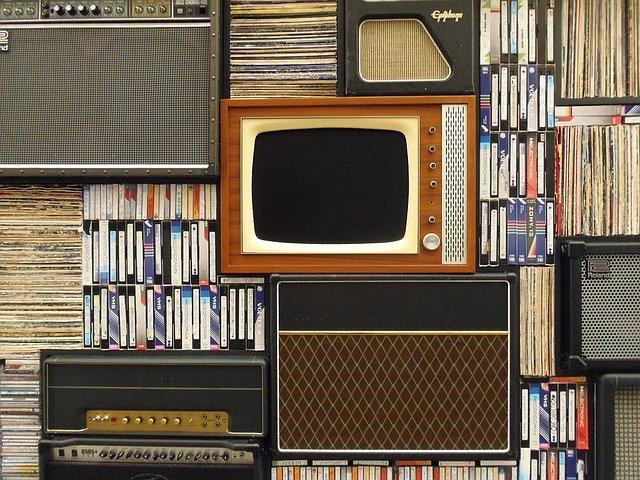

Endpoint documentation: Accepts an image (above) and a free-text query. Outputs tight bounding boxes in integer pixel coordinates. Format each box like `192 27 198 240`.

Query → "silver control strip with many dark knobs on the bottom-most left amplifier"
51 445 253 465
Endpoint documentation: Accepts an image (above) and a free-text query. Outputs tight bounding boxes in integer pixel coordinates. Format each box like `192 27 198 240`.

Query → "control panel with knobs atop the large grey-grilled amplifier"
0 0 210 19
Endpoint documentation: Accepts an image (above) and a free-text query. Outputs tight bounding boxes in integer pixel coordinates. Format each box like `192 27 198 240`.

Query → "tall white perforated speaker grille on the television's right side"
442 105 467 265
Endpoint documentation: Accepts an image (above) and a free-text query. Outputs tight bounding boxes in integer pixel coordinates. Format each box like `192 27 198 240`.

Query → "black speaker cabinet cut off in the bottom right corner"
595 373 640 480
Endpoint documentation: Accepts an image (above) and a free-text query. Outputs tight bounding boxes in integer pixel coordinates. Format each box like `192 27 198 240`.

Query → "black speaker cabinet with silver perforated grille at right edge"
560 237 640 372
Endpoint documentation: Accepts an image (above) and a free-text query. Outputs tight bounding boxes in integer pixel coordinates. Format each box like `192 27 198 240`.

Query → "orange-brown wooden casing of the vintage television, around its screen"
220 95 477 273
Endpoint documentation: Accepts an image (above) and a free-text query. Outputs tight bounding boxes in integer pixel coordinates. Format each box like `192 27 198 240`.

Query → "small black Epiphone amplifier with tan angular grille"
344 0 478 95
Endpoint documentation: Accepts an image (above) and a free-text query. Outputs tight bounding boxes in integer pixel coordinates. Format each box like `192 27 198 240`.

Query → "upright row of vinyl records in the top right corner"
560 0 640 98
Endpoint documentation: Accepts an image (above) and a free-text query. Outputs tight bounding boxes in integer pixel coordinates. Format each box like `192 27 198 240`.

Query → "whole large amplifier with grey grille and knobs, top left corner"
0 0 220 177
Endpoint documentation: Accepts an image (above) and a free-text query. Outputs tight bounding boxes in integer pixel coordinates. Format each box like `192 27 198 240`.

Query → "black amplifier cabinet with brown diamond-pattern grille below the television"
271 275 518 458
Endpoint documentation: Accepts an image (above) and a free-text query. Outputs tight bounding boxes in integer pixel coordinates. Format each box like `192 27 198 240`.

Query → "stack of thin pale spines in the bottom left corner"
0 353 40 480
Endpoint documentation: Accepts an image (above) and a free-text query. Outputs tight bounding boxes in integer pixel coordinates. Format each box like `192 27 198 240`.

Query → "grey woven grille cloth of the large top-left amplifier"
0 25 211 166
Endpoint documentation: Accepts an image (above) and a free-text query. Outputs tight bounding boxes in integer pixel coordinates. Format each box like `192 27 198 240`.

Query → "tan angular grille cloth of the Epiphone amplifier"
360 19 451 82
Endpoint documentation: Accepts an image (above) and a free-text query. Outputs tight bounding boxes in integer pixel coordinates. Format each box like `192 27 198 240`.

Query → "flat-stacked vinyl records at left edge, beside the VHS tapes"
0 186 82 351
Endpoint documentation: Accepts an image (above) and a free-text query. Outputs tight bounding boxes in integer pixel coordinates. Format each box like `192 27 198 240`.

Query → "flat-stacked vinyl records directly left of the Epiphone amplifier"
230 0 337 97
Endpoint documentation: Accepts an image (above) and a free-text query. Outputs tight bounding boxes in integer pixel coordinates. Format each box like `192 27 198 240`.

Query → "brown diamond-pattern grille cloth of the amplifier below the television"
279 333 509 450
